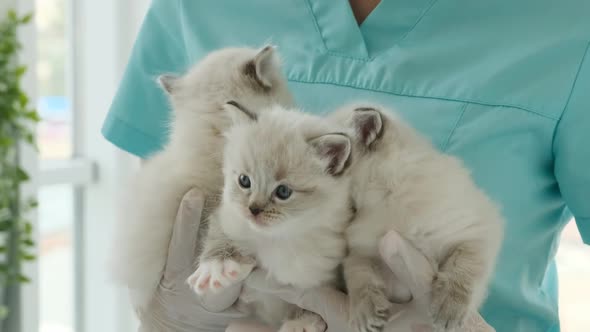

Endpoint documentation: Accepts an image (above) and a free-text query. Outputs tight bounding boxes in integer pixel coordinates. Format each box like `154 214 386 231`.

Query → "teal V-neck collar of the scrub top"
304 0 435 60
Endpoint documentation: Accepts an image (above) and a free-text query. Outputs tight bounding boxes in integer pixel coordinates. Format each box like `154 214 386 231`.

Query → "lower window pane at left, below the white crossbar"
39 185 75 332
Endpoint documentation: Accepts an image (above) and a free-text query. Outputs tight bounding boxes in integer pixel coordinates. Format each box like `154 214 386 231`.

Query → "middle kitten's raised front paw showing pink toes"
187 259 254 295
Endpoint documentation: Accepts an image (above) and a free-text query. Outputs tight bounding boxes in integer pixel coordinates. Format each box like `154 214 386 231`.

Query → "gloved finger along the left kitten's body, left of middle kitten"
164 188 205 282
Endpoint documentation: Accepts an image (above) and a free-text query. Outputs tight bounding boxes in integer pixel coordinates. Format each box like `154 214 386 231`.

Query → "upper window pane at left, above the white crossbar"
35 0 72 159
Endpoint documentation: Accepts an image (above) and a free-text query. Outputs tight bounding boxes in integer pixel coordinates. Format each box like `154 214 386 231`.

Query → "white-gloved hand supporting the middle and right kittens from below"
243 231 495 332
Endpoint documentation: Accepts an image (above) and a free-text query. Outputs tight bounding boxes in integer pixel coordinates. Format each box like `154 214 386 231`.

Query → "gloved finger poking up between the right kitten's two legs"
379 231 435 297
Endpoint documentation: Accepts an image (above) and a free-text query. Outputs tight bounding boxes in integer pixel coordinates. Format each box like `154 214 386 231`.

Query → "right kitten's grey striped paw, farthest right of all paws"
431 273 470 331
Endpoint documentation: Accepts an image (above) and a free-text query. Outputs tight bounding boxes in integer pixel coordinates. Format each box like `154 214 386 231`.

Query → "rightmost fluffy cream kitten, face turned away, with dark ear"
331 106 503 332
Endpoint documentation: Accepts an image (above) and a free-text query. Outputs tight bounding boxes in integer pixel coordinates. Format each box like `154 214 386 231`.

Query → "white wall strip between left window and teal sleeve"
72 0 148 332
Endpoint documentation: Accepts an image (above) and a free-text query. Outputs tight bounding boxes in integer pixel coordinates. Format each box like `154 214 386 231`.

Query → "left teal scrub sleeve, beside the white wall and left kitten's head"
102 0 188 158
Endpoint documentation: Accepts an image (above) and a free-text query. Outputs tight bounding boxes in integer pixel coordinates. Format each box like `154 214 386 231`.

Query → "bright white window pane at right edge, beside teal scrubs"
556 221 590 332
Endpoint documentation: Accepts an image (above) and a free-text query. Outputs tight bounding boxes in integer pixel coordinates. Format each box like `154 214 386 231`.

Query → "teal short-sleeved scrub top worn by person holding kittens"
103 0 590 332
